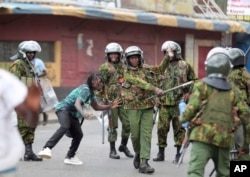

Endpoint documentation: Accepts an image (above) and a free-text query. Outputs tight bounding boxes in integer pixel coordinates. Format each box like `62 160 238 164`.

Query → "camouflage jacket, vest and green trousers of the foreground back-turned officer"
180 81 250 177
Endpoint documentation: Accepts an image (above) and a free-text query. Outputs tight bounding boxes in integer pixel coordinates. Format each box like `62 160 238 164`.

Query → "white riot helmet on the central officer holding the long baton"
125 46 144 67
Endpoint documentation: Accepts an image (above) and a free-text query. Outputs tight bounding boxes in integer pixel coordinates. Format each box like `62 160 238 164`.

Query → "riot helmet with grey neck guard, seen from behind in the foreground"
203 47 232 90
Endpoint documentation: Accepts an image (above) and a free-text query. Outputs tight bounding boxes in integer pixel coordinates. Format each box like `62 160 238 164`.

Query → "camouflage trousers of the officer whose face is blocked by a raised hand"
157 105 185 147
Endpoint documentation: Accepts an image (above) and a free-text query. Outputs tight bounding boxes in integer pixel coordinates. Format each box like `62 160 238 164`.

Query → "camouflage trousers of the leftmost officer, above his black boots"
17 118 35 144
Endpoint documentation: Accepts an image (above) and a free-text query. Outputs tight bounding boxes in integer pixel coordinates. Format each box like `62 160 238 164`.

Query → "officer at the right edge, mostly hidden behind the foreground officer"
228 48 250 160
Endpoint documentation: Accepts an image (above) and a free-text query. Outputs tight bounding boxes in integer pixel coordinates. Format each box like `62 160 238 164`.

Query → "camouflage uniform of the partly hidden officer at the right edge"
228 67 250 160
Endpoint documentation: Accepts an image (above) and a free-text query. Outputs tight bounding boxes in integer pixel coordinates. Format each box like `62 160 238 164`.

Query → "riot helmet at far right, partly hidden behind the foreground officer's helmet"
227 48 246 68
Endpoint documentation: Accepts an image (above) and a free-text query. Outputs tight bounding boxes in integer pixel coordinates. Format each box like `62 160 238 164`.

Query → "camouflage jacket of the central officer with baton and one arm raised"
121 57 168 109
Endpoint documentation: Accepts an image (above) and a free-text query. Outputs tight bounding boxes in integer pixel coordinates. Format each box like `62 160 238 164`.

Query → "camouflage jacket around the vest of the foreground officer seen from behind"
180 81 250 148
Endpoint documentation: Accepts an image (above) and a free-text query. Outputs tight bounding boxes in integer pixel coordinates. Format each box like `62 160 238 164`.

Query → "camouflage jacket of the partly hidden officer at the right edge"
228 68 250 106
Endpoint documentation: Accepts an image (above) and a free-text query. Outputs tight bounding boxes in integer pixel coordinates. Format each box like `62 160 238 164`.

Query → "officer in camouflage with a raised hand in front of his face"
153 41 195 163
